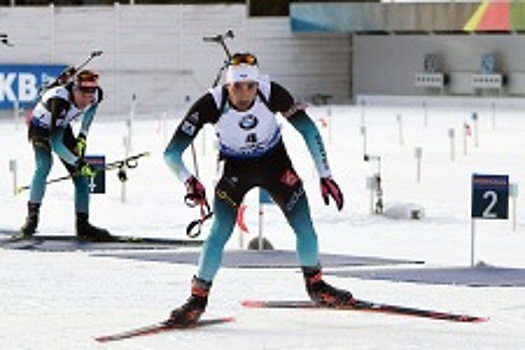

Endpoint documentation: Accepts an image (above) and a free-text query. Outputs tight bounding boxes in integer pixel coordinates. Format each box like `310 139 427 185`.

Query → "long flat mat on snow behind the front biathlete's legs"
97 250 423 268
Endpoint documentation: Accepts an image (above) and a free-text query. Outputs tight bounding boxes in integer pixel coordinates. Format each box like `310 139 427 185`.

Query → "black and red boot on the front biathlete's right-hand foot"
302 266 354 307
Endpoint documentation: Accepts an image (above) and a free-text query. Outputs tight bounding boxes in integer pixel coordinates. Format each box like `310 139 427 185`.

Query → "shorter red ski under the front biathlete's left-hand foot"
95 317 235 343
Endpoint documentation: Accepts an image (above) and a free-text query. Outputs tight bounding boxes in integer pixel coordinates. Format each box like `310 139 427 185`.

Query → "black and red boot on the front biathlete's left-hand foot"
166 277 211 327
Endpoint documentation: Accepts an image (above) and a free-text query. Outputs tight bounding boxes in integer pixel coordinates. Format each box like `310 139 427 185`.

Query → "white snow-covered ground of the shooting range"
0 100 525 349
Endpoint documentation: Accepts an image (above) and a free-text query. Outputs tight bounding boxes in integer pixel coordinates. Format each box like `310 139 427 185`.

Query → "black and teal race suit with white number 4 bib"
164 80 330 281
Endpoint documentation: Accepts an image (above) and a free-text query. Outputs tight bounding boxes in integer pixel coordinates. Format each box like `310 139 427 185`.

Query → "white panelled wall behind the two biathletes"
0 4 352 115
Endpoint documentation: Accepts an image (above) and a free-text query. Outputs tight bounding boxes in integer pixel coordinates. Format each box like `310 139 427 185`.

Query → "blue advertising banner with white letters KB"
0 64 68 109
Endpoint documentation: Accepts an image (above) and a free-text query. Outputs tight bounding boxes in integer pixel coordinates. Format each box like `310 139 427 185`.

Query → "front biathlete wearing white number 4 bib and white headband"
164 53 353 325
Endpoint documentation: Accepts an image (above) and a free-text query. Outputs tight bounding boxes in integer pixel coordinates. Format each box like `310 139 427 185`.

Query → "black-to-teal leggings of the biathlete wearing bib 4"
197 144 319 281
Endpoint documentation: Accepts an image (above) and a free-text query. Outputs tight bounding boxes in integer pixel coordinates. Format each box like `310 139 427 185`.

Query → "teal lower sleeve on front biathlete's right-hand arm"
287 111 331 177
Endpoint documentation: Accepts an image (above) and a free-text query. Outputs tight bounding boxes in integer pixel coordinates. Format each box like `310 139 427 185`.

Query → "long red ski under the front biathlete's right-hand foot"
242 299 488 322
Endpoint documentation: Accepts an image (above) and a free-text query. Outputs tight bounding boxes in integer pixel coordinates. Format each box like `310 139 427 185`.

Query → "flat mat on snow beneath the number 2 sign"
325 266 525 287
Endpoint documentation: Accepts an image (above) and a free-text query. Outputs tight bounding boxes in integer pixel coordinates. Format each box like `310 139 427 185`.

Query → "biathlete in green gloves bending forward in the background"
18 70 113 242
